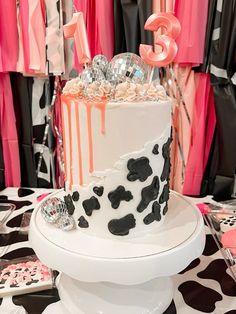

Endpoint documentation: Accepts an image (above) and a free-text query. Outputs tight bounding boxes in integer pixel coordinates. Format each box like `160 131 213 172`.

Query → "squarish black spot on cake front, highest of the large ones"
127 157 152 182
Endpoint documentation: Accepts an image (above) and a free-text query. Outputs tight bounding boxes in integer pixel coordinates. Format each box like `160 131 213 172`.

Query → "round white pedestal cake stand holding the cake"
29 191 205 314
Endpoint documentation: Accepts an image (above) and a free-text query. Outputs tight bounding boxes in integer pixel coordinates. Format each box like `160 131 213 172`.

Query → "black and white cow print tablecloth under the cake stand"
0 188 236 314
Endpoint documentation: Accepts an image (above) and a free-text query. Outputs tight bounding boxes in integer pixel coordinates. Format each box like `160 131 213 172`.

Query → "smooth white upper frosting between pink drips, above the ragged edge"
62 100 171 186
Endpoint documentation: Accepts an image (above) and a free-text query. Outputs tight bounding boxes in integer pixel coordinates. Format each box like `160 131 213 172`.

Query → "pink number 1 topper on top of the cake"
63 12 91 64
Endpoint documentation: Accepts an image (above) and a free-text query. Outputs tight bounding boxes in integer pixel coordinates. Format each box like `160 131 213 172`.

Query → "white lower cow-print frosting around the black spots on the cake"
73 125 170 238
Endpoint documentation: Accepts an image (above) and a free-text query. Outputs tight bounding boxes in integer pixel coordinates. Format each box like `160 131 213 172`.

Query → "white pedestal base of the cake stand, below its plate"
43 274 173 314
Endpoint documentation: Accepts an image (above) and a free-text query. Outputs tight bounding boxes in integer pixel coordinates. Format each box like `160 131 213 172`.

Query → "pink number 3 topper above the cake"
139 13 181 67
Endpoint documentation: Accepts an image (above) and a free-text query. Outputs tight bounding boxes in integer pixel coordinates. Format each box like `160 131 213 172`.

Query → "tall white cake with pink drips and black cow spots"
61 79 171 238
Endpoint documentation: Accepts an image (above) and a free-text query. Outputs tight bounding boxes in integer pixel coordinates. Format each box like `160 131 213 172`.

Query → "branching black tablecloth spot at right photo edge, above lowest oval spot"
197 259 236 297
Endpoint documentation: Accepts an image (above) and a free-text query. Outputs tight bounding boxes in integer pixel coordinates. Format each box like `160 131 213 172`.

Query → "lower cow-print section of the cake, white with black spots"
60 126 171 237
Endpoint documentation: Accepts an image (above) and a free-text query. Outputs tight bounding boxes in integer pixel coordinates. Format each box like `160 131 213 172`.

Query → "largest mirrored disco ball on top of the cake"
106 52 149 85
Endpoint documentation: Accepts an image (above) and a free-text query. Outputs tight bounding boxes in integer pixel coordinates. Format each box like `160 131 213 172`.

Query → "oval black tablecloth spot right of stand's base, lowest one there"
178 281 223 313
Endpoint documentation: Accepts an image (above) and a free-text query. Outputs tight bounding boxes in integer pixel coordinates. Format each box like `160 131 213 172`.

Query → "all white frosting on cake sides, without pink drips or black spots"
62 96 171 238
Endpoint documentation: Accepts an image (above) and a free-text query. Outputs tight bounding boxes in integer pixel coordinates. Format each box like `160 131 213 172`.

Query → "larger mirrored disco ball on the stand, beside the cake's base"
41 197 68 224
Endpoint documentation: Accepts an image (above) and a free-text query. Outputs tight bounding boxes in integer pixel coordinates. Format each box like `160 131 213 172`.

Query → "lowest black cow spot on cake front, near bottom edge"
108 214 136 236
